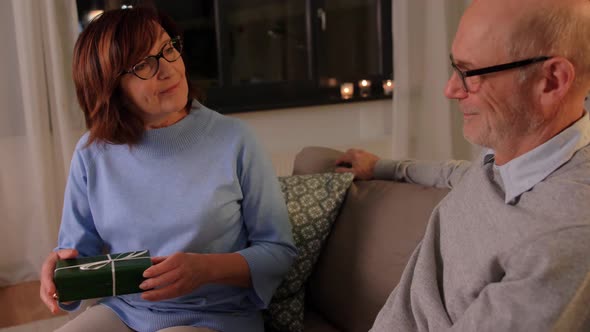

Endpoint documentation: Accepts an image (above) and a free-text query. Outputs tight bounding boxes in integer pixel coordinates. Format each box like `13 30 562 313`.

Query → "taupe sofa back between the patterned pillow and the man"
293 147 448 332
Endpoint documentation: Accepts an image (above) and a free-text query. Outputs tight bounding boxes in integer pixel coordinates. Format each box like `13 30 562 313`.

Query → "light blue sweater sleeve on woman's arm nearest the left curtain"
55 140 103 256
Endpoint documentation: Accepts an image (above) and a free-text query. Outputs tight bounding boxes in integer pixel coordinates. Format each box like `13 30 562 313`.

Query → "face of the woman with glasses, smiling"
121 28 188 129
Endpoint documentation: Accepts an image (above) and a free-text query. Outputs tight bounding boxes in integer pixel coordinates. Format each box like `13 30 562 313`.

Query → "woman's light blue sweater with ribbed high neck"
57 101 296 332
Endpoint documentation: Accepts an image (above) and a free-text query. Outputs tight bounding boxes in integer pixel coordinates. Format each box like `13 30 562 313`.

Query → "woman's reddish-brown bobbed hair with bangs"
72 7 198 145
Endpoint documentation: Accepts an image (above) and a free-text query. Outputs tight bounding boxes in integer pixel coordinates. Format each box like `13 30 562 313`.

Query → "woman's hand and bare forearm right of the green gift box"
139 253 252 301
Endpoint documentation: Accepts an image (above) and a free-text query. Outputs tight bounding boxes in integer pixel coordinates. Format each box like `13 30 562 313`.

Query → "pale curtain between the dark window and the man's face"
392 0 477 160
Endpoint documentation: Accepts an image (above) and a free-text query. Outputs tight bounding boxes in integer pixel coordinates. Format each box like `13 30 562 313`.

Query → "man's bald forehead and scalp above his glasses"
452 0 590 90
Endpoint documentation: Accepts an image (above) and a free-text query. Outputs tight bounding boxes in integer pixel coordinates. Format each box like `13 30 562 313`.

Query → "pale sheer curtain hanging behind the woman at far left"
0 0 84 286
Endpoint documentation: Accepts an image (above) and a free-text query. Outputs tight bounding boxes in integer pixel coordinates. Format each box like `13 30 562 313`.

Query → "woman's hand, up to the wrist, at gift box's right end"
139 253 209 301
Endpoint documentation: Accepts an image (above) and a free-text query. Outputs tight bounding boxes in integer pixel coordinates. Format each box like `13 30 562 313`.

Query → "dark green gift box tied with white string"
53 250 152 302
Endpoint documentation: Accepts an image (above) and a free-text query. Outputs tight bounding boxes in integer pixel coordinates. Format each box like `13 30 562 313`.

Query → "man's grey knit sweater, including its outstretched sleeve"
371 114 590 332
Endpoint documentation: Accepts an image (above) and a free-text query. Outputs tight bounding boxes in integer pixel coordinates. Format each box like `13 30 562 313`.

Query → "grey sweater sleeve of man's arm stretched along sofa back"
374 159 471 189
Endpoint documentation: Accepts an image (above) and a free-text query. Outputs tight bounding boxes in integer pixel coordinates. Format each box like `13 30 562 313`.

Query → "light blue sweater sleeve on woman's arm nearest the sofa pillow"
238 124 297 308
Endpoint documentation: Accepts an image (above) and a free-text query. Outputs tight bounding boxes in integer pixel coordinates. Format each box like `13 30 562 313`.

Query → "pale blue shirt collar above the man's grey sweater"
483 112 590 204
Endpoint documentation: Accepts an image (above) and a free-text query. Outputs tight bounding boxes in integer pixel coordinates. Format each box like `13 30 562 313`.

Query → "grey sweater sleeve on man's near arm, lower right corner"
449 225 590 331
